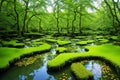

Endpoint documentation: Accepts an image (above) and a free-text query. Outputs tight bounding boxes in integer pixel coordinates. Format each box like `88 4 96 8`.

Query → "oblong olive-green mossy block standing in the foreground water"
71 63 93 80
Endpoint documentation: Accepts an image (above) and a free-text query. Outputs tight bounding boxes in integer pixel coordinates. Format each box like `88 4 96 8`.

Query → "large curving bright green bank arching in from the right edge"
47 44 120 68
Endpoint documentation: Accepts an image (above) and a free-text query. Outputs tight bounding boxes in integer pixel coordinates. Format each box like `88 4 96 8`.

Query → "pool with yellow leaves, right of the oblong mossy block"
83 60 119 80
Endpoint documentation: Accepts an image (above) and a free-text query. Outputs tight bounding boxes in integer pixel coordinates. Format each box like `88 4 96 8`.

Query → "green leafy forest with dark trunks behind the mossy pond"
0 0 120 35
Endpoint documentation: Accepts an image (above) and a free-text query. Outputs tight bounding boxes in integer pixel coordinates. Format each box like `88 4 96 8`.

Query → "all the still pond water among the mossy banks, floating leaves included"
0 36 119 80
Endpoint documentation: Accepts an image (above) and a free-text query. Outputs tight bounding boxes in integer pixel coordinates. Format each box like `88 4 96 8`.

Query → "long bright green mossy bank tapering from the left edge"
0 44 51 69
